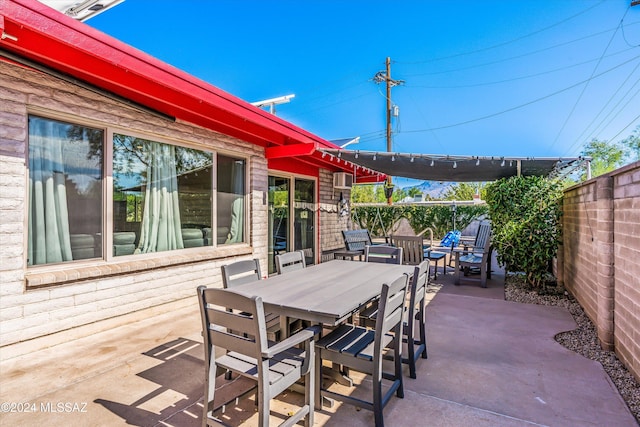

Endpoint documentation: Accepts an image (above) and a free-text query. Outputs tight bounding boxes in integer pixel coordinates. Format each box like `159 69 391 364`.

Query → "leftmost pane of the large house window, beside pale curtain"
27 116 104 265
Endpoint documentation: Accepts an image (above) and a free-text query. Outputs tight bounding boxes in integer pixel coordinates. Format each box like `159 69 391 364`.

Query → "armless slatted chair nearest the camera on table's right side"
315 274 407 427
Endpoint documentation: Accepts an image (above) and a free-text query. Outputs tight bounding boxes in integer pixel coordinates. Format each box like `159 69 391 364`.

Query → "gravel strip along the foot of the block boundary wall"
505 275 640 423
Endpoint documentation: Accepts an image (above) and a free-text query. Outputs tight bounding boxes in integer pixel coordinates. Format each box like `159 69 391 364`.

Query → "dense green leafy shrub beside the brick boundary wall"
486 176 562 290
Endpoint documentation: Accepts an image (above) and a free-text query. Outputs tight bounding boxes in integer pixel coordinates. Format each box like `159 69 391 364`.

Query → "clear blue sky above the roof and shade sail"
87 0 640 182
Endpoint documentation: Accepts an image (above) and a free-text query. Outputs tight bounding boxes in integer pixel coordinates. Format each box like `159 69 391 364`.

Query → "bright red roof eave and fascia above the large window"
0 0 336 148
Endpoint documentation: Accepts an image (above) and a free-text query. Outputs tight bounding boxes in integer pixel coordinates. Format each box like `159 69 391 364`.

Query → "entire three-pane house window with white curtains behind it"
28 116 246 265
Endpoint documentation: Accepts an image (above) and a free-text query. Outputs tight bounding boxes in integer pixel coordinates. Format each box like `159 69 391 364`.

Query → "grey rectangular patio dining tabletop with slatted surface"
233 260 414 326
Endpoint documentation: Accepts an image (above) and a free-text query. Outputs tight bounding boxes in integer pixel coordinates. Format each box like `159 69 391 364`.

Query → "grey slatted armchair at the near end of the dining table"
198 286 320 427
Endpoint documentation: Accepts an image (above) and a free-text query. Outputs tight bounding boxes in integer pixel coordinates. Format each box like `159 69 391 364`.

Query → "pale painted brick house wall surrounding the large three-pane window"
0 61 267 359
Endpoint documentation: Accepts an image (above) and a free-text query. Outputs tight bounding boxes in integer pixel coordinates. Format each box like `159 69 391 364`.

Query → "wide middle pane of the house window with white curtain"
113 133 213 256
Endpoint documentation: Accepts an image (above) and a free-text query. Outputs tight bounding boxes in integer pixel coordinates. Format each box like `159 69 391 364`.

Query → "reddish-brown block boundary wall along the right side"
558 162 640 379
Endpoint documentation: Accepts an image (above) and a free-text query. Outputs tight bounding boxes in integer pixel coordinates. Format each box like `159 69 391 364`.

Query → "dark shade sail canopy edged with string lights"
322 149 591 182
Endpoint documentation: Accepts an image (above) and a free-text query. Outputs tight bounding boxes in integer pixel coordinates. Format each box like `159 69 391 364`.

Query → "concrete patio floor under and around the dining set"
0 262 638 427
